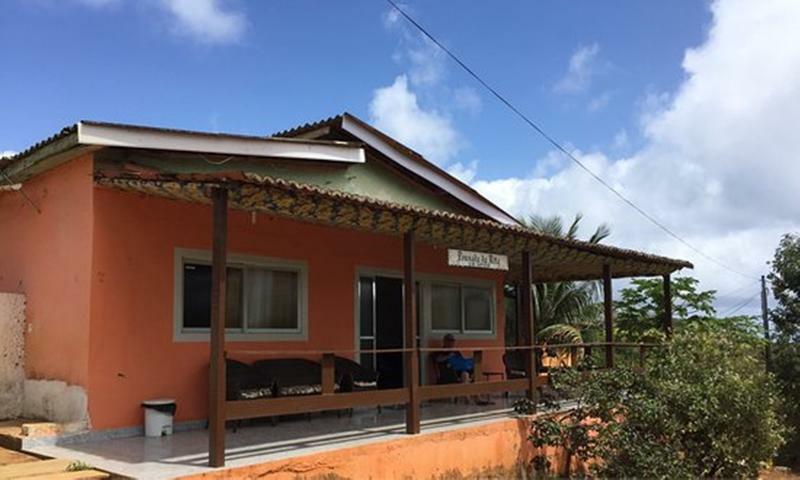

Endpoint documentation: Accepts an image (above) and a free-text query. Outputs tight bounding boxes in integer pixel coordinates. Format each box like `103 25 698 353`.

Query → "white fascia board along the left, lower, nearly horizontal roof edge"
78 122 365 163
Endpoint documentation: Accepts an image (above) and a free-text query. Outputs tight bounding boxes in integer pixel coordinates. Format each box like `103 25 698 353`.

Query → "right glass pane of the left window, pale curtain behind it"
245 267 299 330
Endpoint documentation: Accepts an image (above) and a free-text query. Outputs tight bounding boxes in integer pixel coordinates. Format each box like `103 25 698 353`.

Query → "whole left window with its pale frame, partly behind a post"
175 251 307 340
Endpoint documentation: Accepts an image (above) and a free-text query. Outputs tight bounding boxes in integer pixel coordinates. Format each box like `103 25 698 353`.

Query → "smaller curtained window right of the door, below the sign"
431 283 494 333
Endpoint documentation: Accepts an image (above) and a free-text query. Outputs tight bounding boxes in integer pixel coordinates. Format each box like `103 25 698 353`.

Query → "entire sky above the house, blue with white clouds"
0 0 800 312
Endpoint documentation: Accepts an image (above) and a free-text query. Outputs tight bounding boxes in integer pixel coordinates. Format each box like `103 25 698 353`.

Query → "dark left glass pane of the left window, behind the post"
183 263 242 328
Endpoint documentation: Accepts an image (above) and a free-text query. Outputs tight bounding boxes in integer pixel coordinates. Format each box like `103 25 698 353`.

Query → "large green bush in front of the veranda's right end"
531 321 785 479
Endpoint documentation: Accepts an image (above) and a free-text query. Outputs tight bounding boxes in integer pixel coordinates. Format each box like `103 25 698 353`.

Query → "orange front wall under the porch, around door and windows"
89 188 504 429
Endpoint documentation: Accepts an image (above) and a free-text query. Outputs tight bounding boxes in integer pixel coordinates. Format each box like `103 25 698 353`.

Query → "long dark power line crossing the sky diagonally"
386 0 764 278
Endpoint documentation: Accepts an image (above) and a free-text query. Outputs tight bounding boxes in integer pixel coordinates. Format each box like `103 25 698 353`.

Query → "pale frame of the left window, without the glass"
173 248 308 342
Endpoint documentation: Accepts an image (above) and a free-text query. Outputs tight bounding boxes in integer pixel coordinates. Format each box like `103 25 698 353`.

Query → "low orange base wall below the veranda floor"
182 418 540 480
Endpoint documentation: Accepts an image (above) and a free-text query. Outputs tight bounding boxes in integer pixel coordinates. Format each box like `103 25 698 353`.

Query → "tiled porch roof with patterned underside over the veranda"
95 171 693 282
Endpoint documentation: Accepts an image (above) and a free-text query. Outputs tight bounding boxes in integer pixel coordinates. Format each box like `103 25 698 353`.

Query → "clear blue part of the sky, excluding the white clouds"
0 0 709 179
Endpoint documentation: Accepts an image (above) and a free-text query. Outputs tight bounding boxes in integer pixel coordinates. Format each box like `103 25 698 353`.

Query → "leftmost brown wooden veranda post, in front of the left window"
208 188 228 467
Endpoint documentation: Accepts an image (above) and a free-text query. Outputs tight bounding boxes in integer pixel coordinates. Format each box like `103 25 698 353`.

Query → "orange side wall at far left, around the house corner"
0 155 93 386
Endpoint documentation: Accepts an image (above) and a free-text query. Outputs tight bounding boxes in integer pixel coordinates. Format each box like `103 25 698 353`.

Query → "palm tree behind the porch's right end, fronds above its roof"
523 214 611 344
